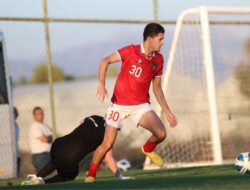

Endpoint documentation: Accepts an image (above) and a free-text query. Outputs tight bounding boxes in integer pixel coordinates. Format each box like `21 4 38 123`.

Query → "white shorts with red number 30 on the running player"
105 103 153 129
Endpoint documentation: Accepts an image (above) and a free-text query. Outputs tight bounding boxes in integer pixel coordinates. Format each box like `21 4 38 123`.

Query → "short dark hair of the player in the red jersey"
143 22 165 41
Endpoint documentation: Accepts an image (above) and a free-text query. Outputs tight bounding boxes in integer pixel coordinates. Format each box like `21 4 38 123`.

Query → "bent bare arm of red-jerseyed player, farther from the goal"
97 53 120 102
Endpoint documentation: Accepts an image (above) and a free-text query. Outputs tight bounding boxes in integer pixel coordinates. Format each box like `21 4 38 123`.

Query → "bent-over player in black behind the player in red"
22 115 129 185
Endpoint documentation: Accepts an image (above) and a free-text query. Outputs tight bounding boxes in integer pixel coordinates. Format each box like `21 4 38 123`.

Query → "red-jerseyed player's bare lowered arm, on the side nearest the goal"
153 77 177 127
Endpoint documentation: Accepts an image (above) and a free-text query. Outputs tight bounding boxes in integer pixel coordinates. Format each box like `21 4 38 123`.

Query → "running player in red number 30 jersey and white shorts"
85 23 177 183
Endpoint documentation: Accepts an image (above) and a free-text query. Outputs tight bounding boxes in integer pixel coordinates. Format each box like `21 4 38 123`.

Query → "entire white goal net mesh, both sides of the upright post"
154 8 250 165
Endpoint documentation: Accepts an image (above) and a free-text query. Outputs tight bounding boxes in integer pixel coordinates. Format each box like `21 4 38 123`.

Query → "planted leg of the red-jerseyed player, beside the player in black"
85 125 118 182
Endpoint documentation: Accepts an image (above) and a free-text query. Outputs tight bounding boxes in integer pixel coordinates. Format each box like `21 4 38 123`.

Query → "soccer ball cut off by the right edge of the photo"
235 152 250 174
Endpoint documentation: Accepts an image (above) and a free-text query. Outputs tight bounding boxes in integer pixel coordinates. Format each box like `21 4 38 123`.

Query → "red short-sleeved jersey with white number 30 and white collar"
111 45 164 106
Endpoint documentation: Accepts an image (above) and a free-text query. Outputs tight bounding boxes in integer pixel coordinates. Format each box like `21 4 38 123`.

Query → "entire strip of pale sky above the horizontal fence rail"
0 0 250 19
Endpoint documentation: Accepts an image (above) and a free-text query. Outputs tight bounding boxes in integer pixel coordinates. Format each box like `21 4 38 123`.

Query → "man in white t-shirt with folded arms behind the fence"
29 107 53 172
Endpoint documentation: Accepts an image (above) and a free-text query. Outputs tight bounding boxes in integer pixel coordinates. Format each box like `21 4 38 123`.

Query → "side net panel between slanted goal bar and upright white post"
158 11 212 166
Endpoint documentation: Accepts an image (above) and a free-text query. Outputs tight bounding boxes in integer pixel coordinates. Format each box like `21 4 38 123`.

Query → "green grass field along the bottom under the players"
0 165 250 190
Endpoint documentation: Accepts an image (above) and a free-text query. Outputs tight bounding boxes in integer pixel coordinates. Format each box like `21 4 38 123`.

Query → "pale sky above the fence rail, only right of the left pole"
48 0 250 19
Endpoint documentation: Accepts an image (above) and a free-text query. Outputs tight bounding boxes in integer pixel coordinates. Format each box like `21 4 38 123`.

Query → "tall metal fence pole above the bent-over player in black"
43 0 56 137
